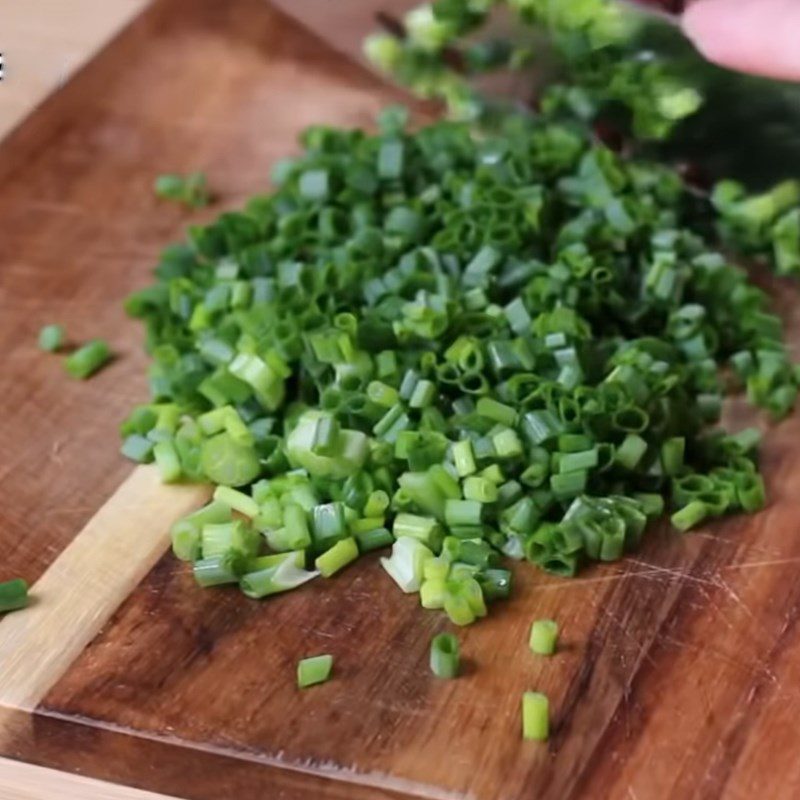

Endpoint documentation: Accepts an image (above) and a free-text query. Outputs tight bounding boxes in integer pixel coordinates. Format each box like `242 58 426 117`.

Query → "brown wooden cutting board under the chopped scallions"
0 0 800 800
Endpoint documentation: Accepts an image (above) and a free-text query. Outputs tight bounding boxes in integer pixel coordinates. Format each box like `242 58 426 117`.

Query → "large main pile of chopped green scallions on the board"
122 97 798 625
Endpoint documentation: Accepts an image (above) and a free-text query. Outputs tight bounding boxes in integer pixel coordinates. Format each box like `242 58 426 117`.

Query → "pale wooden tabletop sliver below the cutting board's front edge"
0 758 182 800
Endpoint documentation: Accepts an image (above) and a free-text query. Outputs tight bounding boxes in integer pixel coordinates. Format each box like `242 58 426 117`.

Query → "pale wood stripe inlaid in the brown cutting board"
0 466 210 711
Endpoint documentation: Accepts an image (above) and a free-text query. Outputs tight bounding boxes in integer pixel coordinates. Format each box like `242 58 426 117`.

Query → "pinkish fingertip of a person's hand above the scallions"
682 0 800 80
